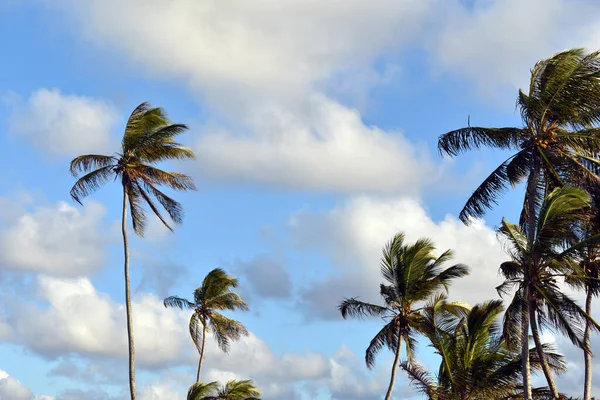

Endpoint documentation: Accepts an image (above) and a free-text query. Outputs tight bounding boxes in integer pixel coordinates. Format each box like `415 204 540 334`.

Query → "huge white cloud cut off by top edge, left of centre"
58 0 429 101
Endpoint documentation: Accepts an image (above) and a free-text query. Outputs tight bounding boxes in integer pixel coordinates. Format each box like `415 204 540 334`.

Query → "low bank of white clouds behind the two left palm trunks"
0 276 412 400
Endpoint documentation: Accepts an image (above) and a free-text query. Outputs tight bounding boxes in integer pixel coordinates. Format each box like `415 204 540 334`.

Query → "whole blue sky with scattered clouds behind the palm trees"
0 0 600 400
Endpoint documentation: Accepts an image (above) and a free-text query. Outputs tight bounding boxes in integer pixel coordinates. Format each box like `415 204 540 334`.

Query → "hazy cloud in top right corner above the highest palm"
424 0 600 97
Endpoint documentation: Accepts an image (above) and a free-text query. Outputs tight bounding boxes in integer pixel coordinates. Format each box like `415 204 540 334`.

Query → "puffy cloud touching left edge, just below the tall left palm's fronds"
0 201 107 276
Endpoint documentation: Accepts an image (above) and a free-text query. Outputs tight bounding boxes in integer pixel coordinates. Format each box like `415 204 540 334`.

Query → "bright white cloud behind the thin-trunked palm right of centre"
290 197 507 318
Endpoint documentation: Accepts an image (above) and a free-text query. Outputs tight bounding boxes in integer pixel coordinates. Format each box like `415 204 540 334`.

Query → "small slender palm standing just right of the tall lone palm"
164 268 248 382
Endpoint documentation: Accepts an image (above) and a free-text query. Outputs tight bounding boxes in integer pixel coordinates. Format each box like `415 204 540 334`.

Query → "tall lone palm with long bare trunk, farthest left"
71 103 196 400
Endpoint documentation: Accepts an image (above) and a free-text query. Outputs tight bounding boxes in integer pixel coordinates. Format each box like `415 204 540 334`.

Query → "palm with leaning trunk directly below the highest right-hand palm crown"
497 186 600 398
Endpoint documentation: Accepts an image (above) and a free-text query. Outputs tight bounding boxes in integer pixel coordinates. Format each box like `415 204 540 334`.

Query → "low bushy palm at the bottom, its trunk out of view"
401 295 566 400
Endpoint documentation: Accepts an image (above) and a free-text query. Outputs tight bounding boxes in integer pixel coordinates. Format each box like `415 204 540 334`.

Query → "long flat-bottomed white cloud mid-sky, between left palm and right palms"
196 96 436 193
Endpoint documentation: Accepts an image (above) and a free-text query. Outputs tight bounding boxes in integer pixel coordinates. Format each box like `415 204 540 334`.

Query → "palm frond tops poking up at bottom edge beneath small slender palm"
187 379 260 400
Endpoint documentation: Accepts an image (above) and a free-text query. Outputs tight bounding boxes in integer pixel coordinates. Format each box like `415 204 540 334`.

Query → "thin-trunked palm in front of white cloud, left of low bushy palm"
339 233 468 400
